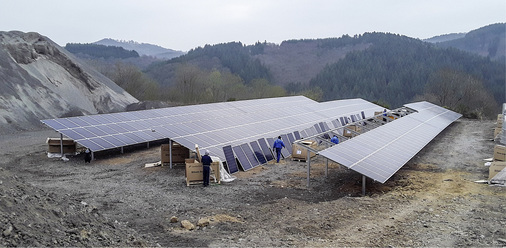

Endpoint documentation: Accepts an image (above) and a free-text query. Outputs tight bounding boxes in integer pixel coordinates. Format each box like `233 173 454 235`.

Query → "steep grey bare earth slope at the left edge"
0 31 138 131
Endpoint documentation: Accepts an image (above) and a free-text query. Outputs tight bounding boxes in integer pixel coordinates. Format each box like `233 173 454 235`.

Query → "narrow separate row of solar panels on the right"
319 102 461 183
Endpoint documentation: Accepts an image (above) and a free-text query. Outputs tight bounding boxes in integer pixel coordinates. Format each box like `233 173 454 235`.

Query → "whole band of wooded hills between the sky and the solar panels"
64 24 506 117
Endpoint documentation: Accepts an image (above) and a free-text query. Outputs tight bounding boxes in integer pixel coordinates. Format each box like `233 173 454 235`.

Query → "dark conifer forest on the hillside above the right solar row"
310 33 505 114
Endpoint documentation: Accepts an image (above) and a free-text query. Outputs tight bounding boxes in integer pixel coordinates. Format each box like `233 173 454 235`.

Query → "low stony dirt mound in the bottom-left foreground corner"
0 168 145 247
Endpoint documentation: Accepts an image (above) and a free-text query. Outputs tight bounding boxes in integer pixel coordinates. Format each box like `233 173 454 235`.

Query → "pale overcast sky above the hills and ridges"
0 0 506 51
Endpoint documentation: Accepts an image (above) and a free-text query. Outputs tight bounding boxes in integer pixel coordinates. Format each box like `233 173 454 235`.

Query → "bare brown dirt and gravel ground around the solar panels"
0 119 506 247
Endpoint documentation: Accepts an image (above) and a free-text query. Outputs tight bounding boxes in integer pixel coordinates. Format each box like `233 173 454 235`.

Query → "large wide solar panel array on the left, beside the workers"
42 96 382 170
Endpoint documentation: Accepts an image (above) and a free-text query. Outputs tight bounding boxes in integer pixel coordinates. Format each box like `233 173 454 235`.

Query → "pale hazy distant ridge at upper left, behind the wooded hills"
93 38 185 59
